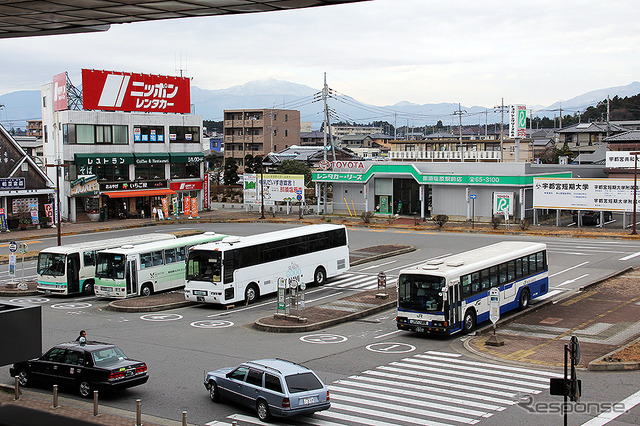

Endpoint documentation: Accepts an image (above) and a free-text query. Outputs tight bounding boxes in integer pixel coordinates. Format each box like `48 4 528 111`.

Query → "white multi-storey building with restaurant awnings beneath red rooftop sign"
41 70 208 222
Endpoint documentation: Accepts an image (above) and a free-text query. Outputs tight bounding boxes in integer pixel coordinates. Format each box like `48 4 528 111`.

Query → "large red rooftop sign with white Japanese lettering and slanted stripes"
82 69 191 113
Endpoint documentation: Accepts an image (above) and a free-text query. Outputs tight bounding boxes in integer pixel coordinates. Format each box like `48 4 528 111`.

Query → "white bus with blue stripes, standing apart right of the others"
396 241 549 334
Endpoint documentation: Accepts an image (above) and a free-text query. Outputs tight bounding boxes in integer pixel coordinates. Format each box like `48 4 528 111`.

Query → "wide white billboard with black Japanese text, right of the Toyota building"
533 178 640 212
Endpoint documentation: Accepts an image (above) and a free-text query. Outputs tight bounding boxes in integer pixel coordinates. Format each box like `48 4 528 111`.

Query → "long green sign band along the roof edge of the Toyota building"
312 164 571 186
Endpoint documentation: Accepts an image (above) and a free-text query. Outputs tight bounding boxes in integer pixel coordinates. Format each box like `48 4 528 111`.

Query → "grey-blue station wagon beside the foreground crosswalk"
204 359 331 421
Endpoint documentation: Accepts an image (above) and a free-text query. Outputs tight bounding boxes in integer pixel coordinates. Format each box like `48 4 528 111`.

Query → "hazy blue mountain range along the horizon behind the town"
0 79 640 130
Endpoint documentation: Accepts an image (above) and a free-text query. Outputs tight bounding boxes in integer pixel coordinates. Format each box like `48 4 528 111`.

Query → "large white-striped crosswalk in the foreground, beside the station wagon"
207 351 562 426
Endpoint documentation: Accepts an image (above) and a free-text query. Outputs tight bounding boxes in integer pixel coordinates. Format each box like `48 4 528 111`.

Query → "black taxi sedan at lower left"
9 341 149 398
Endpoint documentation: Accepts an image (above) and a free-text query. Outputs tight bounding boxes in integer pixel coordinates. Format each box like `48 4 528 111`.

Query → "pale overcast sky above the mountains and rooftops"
0 0 640 107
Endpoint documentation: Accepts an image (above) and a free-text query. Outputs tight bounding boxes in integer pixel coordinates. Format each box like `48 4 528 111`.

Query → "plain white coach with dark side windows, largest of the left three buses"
184 224 349 304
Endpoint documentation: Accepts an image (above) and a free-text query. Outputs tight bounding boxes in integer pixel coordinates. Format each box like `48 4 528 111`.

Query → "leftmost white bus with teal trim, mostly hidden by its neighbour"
36 234 176 295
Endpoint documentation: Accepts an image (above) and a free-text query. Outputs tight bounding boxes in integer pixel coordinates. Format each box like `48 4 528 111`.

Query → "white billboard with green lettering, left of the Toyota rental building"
244 173 304 204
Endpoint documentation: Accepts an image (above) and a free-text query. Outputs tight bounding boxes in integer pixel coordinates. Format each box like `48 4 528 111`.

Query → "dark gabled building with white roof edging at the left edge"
0 125 56 229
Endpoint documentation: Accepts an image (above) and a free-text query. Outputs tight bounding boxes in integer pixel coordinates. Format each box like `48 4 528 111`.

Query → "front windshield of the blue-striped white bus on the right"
398 274 445 312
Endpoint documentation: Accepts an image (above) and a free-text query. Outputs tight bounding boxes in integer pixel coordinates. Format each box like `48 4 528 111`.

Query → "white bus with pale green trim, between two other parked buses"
95 232 226 299
